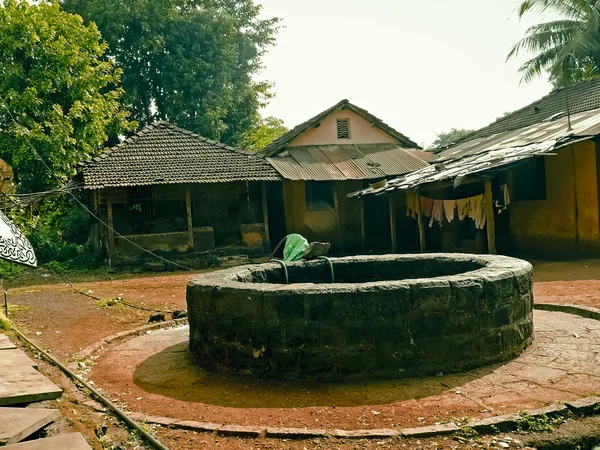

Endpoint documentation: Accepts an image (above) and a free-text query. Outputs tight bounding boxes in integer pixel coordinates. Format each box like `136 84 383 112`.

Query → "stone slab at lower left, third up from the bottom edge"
0 366 62 406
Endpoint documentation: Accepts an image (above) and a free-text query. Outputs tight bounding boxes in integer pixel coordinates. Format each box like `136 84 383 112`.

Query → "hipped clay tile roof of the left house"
81 121 281 189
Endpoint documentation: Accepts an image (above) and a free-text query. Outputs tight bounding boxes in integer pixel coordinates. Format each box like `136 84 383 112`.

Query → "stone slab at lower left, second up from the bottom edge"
0 408 60 445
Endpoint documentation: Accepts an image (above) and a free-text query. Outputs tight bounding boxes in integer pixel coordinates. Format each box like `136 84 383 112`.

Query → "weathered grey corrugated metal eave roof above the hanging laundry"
349 109 600 197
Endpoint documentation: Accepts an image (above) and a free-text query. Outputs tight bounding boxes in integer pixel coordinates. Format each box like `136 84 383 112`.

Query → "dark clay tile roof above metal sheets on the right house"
458 78 600 143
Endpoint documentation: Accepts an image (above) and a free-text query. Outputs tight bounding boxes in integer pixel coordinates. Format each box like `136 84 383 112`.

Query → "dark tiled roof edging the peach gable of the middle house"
262 100 420 156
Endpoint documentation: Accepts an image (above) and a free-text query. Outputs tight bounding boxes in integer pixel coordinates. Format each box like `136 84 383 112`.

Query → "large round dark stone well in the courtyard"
187 254 533 380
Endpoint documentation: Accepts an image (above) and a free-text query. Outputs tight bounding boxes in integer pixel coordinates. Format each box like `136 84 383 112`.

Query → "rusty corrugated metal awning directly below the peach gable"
267 144 428 181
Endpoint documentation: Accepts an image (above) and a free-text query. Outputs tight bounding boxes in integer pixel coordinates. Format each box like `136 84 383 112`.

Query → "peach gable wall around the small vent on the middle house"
288 110 399 147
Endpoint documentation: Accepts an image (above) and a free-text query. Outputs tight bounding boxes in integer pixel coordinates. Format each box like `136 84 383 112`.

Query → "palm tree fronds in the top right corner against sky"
507 0 600 87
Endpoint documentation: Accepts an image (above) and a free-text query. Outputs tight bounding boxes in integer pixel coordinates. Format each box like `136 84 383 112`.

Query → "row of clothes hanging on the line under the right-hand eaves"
406 184 510 230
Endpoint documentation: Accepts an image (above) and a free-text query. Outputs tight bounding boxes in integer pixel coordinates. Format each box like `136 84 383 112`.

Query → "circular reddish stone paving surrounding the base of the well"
91 311 600 429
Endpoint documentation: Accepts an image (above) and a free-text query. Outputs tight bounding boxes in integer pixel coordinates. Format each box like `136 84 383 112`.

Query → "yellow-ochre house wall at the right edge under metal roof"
508 140 600 255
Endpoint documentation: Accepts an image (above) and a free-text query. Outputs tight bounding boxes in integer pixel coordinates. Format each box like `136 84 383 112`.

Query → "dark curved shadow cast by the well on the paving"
133 342 499 408
